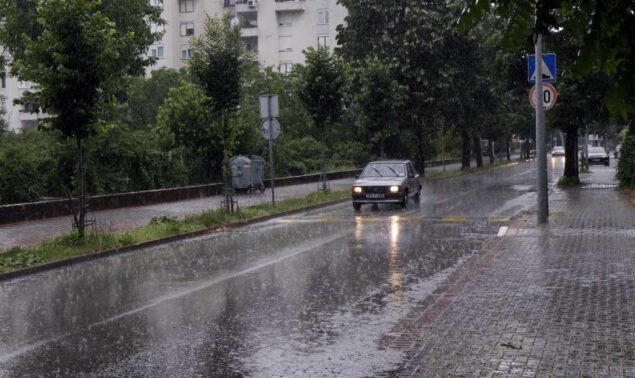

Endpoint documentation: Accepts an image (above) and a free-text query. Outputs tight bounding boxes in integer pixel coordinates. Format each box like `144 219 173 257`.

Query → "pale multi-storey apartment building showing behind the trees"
0 0 347 130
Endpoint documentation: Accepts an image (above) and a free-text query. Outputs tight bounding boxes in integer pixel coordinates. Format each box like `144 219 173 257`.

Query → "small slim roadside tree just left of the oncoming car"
296 47 346 190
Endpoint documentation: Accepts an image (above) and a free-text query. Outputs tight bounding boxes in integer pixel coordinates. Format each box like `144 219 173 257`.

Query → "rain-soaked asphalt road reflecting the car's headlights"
0 158 580 377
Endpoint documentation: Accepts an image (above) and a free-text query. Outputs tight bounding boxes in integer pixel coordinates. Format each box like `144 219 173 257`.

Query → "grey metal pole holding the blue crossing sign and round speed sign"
535 33 549 224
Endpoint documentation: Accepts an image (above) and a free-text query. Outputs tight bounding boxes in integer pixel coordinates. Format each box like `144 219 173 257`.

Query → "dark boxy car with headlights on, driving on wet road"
352 160 421 211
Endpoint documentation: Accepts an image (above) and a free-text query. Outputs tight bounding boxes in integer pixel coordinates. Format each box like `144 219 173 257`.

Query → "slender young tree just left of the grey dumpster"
189 15 250 210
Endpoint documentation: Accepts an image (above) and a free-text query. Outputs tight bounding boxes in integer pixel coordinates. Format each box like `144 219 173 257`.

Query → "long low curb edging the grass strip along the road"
0 198 350 283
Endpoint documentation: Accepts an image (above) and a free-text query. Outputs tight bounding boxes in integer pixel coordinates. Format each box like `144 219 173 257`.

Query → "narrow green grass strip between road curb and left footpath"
0 190 350 273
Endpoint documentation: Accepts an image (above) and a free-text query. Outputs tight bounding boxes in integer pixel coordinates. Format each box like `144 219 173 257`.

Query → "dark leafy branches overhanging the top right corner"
459 0 635 119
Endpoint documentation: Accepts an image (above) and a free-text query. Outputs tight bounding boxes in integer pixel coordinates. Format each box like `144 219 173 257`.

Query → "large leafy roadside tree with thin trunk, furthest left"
0 0 162 236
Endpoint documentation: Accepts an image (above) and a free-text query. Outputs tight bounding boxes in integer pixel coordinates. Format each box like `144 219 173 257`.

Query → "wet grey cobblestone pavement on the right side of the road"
387 162 635 377
